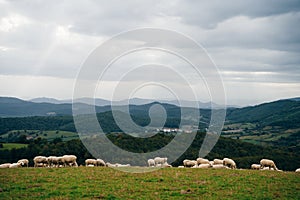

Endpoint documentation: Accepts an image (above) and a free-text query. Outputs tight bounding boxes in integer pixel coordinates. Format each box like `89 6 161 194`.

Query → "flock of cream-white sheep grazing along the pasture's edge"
0 155 300 172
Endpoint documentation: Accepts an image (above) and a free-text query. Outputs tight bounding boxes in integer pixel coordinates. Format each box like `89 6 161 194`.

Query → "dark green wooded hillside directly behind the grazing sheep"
0 133 300 171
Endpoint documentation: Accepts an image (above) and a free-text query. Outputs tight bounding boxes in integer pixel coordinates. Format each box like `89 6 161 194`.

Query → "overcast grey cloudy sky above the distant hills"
0 0 300 105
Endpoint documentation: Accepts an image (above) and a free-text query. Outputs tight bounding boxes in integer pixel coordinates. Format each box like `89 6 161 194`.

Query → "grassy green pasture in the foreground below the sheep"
0 167 300 199
